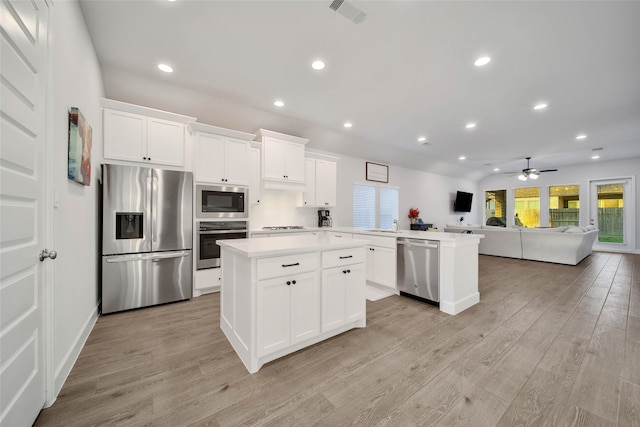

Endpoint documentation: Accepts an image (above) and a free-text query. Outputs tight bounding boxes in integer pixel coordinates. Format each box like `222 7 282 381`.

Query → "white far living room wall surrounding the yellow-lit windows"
475 157 640 252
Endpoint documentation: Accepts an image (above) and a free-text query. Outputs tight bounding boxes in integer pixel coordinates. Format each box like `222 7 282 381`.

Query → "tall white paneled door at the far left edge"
0 0 51 426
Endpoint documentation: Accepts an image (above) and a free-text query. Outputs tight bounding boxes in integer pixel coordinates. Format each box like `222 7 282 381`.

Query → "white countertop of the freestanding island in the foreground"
216 235 369 258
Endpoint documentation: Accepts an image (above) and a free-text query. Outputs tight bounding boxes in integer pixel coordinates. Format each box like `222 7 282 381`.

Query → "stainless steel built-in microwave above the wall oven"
196 185 249 218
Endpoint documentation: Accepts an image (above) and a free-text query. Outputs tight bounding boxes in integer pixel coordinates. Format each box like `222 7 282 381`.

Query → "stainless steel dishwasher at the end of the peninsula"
397 238 440 306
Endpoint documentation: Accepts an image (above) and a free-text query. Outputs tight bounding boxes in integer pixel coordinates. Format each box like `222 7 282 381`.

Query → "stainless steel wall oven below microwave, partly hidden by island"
196 221 248 270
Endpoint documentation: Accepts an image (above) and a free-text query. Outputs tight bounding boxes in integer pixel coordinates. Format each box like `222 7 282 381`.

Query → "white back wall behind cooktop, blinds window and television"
250 153 482 229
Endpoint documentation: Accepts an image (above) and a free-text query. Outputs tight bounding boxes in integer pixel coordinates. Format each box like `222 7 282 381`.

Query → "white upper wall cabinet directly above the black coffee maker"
302 157 338 208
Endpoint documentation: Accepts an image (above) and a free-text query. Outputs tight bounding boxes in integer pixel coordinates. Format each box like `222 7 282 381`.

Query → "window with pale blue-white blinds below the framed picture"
353 184 399 229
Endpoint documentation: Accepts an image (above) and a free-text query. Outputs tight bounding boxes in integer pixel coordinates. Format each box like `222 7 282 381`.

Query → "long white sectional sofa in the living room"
444 224 598 265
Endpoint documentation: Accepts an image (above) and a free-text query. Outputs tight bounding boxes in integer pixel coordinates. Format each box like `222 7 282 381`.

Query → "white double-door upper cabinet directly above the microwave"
189 123 255 185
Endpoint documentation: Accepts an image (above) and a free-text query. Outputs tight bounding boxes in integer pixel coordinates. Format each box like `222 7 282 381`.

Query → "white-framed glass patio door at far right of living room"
589 178 635 251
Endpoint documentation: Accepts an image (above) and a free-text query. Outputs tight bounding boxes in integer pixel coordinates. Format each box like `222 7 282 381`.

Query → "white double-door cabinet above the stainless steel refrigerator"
101 99 195 168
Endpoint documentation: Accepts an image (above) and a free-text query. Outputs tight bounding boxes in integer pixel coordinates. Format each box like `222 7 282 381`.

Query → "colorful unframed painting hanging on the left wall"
67 107 92 185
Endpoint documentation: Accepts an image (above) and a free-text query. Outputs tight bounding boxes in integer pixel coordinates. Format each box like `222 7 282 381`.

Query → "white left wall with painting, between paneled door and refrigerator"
50 1 104 395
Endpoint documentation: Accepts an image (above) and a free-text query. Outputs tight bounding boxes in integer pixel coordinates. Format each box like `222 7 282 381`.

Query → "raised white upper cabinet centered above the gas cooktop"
256 129 309 190
